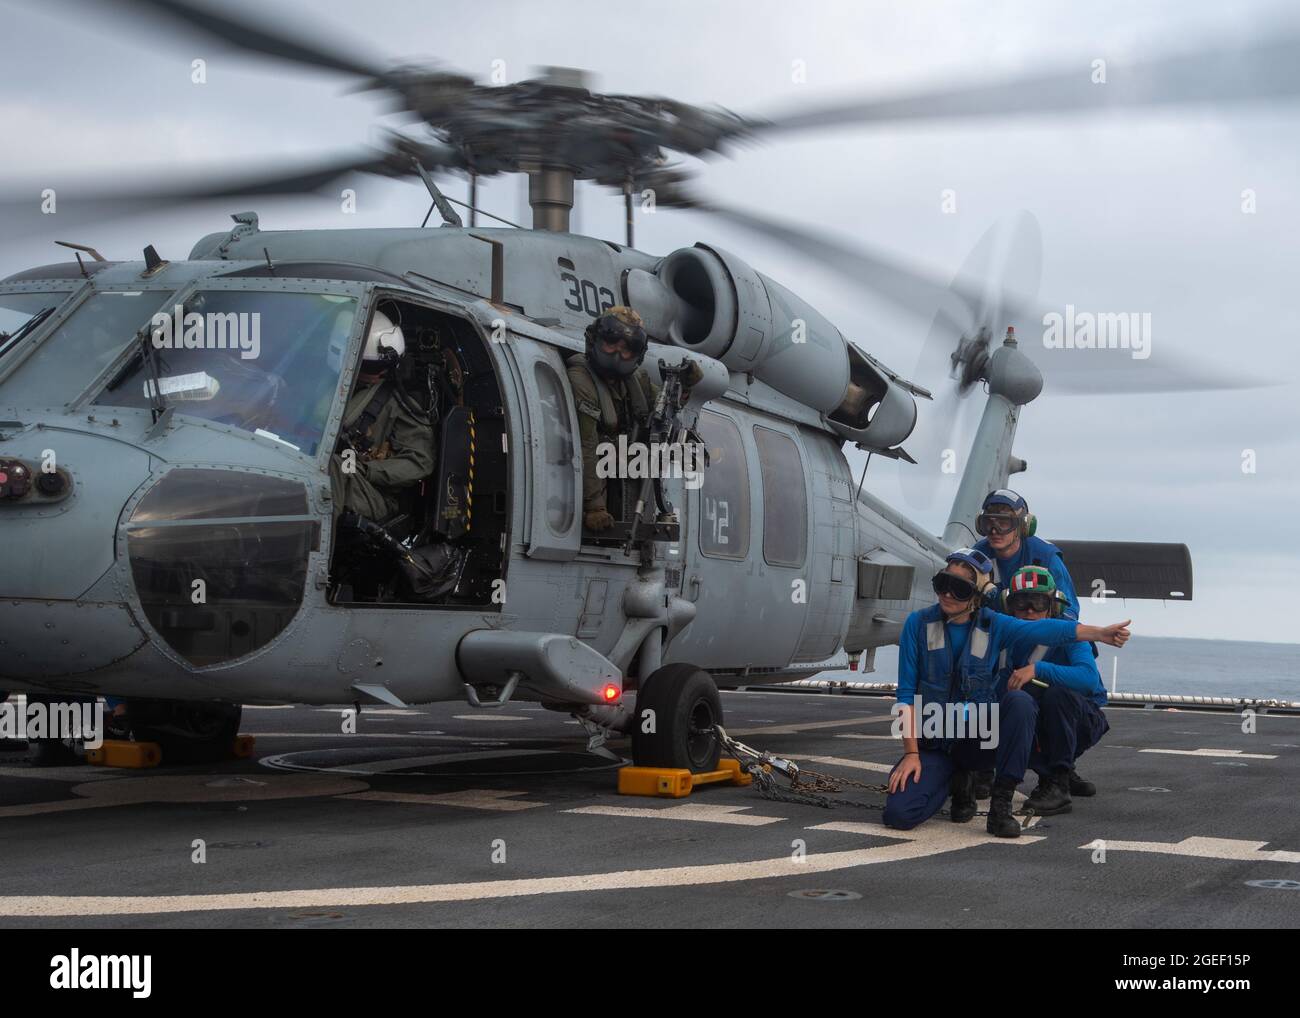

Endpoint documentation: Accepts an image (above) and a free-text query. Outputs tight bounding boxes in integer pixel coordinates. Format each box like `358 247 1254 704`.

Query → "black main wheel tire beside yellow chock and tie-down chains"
632 664 723 774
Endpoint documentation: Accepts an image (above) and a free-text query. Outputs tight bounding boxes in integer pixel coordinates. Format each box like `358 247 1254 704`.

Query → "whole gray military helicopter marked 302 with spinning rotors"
0 0 1300 771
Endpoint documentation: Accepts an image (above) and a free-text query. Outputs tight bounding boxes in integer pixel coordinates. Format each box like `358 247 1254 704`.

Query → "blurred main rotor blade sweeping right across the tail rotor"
693 200 1266 395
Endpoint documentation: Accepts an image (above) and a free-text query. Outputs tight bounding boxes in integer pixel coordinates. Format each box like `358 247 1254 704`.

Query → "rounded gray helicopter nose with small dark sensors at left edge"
0 428 150 680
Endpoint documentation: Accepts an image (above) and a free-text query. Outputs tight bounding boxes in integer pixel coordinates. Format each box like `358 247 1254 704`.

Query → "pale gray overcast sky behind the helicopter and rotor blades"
0 0 1300 642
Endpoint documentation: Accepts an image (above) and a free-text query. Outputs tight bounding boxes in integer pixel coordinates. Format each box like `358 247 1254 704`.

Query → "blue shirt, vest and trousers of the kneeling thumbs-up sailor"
883 605 1091 831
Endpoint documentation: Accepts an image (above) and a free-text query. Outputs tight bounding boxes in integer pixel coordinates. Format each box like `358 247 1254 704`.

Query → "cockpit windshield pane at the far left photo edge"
0 290 172 407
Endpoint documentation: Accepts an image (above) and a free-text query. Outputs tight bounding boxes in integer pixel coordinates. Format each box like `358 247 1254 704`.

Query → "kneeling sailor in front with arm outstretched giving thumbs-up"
883 549 1128 837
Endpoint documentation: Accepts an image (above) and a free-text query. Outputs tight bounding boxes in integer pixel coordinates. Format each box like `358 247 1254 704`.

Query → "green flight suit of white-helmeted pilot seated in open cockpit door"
329 381 437 521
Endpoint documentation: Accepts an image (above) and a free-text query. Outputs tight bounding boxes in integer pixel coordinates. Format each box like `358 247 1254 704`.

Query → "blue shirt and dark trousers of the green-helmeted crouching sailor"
1002 644 1110 775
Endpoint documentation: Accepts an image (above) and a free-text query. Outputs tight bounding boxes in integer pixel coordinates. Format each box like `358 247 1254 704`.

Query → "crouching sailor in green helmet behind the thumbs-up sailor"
1004 566 1110 816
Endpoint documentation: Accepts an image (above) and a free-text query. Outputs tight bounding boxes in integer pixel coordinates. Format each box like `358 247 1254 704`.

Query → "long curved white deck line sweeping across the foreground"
0 823 1041 918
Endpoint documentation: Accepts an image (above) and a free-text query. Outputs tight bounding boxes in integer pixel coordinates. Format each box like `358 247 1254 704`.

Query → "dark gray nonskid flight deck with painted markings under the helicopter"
0 690 1300 928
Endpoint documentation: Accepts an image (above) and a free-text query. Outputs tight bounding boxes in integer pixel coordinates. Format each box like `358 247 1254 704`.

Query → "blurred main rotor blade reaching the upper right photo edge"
751 35 1300 133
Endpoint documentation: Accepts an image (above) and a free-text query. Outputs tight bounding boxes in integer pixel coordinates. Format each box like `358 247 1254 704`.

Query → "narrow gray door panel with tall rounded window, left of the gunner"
511 334 582 559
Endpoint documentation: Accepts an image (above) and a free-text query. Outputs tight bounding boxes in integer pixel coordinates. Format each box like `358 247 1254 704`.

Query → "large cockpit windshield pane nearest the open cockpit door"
95 290 356 456
